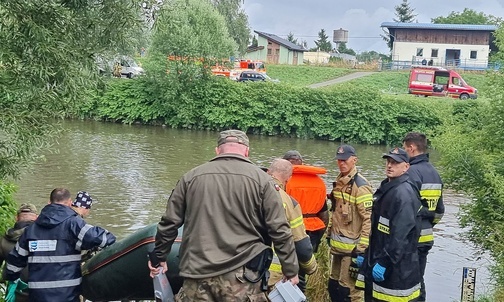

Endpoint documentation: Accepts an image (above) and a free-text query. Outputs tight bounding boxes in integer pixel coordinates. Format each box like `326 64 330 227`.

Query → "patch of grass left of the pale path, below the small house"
266 64 353 87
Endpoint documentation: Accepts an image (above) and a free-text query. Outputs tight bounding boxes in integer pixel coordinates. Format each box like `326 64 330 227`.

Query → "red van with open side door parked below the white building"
408 66 478 100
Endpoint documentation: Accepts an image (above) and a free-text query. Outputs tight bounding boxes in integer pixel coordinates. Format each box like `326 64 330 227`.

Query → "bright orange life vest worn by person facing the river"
285 165 327 231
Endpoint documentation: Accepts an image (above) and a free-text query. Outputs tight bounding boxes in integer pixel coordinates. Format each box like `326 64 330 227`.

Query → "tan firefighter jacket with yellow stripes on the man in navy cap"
328 167 373 254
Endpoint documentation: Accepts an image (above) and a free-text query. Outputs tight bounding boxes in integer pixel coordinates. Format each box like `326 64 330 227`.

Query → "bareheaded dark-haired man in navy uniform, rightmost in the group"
403 132 445 301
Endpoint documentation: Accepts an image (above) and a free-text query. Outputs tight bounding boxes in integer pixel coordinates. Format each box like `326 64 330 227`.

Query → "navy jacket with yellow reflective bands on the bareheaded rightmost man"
408 154 445 247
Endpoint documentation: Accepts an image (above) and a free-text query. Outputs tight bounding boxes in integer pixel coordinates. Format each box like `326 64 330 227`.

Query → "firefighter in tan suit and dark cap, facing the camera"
327 145 373 302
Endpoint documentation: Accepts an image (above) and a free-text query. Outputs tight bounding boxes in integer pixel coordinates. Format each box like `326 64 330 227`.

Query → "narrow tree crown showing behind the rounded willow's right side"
211 0 250 55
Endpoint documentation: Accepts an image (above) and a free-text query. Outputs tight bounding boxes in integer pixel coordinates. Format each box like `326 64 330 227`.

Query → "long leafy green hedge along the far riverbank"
79 77 453 144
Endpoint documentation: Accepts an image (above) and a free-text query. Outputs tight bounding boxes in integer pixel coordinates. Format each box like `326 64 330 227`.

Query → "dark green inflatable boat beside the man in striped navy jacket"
82 224 183 301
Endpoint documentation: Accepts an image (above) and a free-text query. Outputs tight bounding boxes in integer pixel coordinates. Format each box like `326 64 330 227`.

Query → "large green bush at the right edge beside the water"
434 74 504 293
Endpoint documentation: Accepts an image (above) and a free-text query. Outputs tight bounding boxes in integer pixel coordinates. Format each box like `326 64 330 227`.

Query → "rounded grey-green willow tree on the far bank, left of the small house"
148 0 237 79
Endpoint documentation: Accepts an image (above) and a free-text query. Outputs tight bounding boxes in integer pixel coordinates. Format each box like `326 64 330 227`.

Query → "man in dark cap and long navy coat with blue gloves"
356 148 422 302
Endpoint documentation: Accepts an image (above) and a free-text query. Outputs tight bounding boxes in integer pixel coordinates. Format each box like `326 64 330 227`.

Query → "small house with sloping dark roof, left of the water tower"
245 30 306 65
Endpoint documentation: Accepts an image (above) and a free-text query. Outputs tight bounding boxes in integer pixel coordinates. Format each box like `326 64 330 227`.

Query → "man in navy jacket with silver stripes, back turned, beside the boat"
6 188 116 302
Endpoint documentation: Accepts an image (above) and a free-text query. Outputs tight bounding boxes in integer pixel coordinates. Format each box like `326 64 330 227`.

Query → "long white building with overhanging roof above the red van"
381 22 497 69
